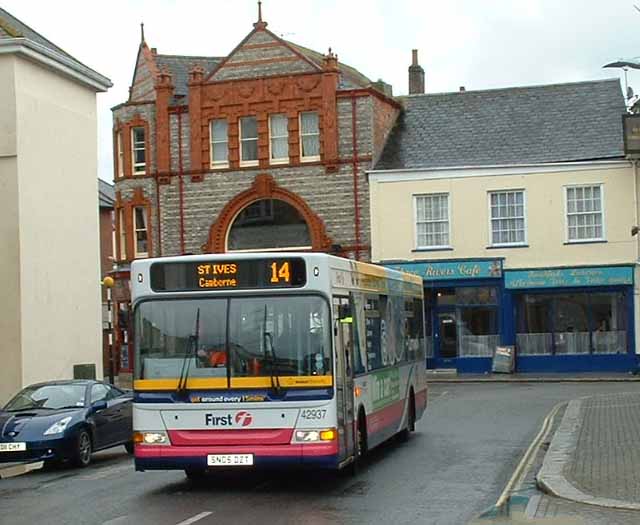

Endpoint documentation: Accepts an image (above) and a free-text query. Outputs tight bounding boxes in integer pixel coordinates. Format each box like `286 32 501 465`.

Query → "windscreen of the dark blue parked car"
4 384 86 412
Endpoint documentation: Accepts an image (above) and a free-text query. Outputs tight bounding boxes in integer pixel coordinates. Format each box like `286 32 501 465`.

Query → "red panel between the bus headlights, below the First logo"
169 428 293 446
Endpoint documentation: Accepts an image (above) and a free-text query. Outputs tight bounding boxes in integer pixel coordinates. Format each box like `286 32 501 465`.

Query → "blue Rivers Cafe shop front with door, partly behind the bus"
387 259 506 373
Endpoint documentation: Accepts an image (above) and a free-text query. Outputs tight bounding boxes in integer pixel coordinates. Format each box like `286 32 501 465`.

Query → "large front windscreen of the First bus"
135 295 331 379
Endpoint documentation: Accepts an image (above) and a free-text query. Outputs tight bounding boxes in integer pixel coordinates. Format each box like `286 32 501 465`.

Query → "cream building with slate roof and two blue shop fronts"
369 80 640 373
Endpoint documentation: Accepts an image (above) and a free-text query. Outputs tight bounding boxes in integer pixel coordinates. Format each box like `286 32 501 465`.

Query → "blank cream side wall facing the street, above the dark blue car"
16 58 102 384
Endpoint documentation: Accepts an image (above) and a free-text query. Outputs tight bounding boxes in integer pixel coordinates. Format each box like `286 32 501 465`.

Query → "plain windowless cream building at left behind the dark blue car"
0 9 111 405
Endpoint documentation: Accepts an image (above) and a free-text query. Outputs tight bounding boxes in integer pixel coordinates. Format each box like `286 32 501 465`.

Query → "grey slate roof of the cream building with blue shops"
375 79 625 170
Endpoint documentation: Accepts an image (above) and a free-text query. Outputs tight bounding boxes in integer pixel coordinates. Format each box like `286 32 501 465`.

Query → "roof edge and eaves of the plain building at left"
0 7 112 90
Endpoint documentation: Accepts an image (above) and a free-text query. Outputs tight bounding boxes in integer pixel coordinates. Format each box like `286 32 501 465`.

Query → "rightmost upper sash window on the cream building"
565 185 604 242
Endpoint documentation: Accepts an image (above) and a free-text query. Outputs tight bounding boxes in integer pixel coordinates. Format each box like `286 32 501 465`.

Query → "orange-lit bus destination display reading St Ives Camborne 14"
150 258 307 292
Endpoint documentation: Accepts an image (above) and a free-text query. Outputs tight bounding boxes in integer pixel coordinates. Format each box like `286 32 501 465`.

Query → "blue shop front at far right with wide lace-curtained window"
504 266 636 373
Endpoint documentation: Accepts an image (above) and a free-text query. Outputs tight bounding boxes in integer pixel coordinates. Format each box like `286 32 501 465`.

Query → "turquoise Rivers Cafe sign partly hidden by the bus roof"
385 259 502 281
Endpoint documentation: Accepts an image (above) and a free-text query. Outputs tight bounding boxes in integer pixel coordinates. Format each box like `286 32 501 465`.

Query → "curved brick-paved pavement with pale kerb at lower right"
536 391 640 510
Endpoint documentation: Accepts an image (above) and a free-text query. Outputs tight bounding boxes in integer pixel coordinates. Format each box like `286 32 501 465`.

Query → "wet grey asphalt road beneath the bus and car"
0 383 638 525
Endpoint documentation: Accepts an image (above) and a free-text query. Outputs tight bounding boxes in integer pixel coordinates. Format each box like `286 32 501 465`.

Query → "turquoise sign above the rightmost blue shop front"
504 266 633 289
